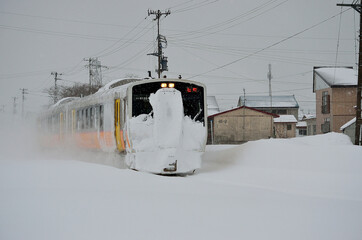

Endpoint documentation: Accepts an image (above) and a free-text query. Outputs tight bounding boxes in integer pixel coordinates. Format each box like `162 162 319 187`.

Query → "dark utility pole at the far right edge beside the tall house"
337 0 362 145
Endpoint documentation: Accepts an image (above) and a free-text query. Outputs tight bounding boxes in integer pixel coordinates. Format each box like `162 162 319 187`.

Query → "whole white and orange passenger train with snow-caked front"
38 78 207 175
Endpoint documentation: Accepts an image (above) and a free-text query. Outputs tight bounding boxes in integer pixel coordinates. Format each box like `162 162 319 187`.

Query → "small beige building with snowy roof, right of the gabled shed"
274 115 298 138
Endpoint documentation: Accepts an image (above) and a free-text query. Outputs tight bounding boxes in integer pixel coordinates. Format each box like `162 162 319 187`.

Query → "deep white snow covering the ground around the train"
0 116 362 240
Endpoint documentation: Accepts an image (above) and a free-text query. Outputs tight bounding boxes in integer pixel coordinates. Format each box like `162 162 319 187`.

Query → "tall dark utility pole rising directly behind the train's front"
148 10 171 78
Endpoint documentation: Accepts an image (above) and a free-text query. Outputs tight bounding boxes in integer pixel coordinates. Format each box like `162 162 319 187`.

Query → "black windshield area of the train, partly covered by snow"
132 81 205 123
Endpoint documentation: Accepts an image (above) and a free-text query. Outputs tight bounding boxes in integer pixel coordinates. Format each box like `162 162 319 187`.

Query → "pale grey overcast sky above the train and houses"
0 0 359 113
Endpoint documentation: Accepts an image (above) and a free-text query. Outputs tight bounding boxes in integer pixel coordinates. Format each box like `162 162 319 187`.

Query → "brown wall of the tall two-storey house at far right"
316 87 357 134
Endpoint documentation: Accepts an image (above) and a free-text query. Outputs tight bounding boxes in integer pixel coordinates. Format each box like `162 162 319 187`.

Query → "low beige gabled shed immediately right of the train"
208 106 279 144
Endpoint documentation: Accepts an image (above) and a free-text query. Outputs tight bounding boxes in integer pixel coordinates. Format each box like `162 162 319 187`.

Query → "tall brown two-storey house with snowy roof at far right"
313 67 357 134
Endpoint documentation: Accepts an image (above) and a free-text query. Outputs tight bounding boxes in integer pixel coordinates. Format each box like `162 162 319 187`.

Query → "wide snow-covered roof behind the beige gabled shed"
239 95 299 108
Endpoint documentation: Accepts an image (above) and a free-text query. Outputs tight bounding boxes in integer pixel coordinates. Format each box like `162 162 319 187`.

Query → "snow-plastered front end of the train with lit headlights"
125 79 207 175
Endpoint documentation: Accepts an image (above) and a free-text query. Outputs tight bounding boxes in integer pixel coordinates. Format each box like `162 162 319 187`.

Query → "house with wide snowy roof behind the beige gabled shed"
238 95 299 119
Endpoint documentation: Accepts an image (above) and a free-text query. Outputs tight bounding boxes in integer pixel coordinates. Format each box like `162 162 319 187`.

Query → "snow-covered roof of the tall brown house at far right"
314 67 357 86
